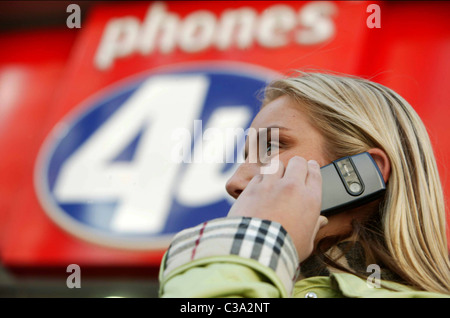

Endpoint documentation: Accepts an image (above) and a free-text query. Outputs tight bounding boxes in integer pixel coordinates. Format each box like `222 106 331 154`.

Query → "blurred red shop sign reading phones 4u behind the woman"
0 1 450 266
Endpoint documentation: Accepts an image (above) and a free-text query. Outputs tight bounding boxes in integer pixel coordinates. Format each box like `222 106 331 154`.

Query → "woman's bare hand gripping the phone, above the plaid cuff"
228 156 327 262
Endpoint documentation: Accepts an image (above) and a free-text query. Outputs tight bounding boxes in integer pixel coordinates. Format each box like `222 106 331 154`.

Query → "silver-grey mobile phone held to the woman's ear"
320 152 386 216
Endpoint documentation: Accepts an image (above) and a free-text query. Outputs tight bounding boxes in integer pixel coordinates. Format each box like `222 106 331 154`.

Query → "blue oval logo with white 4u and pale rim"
35 65 274 249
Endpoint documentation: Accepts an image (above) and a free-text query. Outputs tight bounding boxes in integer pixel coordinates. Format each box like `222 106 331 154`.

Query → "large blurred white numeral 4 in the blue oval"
54 75 208 233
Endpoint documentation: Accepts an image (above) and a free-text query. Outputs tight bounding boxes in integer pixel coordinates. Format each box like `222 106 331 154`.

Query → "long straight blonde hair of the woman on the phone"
263 72 450 293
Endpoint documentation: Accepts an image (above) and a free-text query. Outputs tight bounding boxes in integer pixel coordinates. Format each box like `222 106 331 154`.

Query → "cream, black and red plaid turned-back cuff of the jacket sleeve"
163 217 300 291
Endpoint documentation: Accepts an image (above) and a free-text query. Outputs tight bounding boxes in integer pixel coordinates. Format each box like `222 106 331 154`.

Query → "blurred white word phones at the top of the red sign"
94 2 337 70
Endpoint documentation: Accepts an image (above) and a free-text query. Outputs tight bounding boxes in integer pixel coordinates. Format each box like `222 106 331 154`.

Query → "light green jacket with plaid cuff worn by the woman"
159 218 449 298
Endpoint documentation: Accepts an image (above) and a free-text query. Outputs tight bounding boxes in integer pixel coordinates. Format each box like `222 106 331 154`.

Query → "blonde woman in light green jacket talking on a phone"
160 73 450 297
